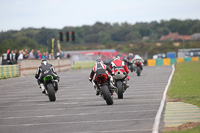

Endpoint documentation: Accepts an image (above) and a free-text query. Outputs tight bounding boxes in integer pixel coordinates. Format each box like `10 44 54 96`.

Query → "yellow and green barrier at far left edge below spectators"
0 65 19 79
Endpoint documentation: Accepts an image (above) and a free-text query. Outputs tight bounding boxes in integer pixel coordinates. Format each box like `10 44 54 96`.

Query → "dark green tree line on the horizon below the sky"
0 19 200 53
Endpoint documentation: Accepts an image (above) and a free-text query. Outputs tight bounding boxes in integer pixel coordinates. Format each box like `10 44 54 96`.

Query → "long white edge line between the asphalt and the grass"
152 64 175 133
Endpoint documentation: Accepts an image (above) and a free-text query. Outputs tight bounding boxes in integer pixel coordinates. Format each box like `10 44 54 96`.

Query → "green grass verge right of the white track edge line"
168 62 200 107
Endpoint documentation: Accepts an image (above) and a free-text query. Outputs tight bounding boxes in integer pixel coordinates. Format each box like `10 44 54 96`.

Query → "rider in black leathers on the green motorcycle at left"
35 59 60 94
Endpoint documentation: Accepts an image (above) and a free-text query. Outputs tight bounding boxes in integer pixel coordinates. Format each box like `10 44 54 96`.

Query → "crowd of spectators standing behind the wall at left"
2 49 71 64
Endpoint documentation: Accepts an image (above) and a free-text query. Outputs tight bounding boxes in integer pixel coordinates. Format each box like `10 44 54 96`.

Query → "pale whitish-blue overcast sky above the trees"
0 0 200 31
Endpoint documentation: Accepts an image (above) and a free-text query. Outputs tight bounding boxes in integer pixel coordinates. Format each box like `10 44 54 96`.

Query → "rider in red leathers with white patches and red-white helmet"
110 56 129 90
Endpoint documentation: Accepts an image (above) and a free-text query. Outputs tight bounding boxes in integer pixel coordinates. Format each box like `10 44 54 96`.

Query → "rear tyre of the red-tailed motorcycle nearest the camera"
101 85 113 105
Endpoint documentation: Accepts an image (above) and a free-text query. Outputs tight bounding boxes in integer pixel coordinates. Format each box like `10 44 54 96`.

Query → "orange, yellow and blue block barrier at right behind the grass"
147 56 200 66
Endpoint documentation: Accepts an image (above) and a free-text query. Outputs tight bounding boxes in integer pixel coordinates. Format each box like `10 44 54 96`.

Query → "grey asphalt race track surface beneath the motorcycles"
0 66 172 133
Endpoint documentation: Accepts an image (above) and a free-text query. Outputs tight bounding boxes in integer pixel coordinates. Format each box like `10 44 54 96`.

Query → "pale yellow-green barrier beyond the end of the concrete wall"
72 61 95 69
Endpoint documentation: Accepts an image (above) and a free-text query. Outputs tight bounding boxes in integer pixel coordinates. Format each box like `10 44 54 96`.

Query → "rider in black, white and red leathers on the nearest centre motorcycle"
88 59 115 95
